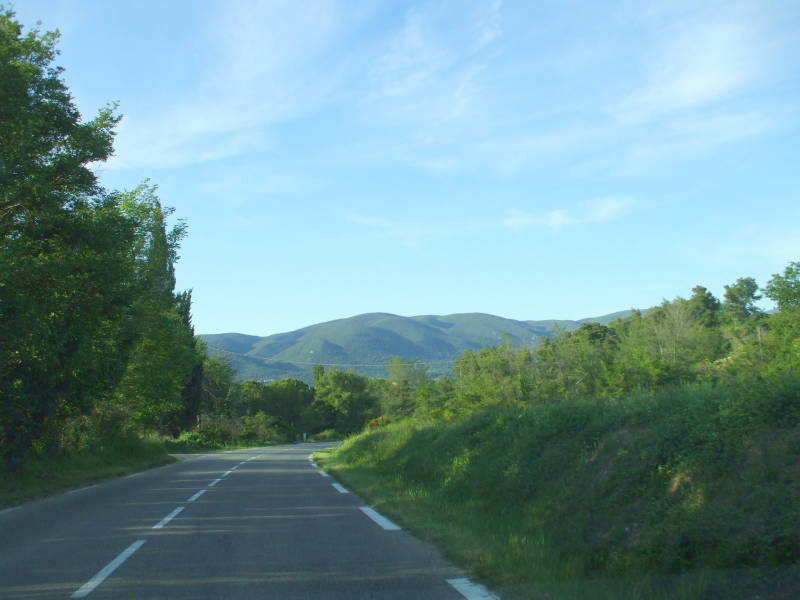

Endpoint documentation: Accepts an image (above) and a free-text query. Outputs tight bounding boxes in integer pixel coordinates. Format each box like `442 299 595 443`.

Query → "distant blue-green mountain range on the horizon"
200 311 631 382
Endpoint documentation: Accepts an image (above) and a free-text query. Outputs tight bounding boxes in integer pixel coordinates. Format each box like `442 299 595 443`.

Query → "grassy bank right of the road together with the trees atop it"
318 270 800 600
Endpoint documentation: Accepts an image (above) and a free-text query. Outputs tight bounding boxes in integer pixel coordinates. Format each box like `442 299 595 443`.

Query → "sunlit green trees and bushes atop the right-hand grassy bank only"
403 274 800 419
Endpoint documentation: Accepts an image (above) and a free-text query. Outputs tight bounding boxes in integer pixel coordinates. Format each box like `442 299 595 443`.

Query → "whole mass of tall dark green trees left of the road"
0 9 204 475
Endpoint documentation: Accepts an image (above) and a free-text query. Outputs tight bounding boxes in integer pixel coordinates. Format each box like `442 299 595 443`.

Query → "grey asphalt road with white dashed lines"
0 444 491 600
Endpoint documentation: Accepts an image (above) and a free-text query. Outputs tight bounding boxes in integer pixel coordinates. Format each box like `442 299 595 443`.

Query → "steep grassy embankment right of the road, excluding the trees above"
319 376 800 600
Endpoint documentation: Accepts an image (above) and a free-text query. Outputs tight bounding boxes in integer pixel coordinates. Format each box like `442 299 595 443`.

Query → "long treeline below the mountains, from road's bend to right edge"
188 262 800 441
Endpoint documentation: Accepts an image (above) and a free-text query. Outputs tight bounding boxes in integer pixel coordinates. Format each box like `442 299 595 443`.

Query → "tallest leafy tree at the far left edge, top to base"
0 8 126 468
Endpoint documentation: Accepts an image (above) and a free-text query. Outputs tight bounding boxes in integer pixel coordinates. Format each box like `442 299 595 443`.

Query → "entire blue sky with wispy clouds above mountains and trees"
14 0 800 335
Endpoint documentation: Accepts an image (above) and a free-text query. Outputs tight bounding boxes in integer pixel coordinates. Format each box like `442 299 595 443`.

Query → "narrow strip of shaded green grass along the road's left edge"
0 435 175 507
